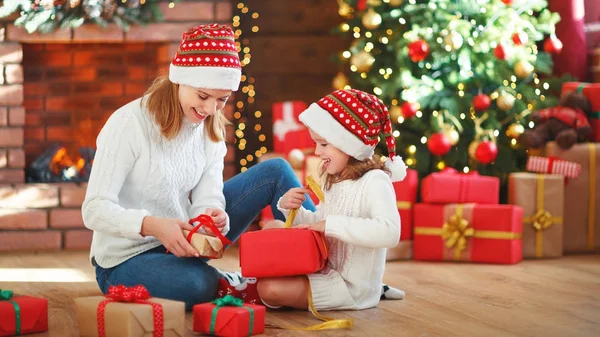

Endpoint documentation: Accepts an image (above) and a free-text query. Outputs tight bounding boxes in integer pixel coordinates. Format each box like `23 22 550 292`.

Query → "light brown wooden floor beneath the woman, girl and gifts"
0 250 600 337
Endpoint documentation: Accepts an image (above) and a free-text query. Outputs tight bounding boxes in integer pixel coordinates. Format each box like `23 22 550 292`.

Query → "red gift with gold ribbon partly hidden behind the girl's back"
393 169 419 241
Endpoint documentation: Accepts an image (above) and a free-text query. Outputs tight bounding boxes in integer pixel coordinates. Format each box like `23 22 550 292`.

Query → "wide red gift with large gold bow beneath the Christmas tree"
413 204 523 264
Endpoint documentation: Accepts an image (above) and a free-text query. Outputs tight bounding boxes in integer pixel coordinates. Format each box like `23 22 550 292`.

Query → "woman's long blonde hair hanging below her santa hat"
144 75 230 142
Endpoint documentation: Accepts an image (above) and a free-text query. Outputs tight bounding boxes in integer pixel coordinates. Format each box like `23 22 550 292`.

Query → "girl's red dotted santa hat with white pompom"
299 89 406 181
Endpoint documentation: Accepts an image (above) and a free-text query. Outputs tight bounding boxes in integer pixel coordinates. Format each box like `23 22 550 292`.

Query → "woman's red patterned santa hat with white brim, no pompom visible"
169 23 242 91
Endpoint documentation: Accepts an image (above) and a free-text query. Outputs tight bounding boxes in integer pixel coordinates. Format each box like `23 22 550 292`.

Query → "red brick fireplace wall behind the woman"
0 0 235 251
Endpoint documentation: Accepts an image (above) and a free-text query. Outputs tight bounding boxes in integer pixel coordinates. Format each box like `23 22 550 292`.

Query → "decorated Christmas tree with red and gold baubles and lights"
333 0 562 198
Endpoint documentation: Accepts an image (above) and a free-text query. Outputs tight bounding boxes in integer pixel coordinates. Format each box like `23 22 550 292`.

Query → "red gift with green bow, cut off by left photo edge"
0 289 48 336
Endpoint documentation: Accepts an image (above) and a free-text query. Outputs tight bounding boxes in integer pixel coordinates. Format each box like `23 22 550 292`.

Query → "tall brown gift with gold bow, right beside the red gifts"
508 172 564 258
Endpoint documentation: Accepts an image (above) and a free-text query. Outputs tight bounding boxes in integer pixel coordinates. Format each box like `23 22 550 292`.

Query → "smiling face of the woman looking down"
179 85 231 123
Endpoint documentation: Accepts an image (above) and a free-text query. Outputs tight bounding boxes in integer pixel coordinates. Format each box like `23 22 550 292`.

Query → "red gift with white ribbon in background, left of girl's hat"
273 101 314 155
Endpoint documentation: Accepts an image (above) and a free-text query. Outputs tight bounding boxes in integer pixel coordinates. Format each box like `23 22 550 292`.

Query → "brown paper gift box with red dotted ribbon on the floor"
75 296 185 337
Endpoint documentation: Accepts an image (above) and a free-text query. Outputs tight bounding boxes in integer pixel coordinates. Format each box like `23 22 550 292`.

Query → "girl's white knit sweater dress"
278 170 400 310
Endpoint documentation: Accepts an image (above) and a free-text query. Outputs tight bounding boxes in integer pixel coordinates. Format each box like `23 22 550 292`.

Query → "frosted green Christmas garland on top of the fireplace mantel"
0 0 163 34
